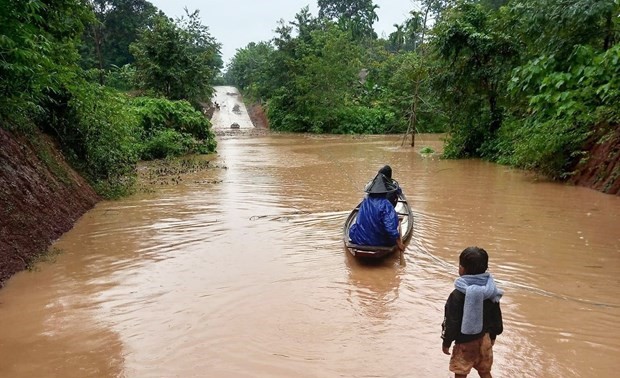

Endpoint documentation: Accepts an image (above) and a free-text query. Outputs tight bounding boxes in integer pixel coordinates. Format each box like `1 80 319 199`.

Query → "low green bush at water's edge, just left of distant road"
132 97 217 160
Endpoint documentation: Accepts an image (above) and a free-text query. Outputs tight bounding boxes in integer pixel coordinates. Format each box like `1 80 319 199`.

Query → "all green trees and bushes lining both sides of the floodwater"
0 0 620 193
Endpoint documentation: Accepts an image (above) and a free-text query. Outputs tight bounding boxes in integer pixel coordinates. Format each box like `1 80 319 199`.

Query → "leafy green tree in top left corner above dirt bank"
0 0 89 130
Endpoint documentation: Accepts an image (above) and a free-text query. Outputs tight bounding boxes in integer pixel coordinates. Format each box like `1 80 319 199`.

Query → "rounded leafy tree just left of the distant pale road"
130 11 222 107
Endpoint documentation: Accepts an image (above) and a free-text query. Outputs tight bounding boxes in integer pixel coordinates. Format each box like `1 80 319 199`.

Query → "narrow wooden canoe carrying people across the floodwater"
343 194 413 259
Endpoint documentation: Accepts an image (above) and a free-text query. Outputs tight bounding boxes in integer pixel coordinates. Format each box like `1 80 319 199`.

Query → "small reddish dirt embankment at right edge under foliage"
570 125 620 195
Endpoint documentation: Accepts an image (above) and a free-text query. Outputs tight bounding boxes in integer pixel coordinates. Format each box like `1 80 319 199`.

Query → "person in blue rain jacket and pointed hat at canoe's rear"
349 173 405 251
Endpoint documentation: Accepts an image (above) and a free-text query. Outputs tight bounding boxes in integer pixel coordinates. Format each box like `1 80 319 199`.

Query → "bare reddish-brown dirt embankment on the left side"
0 129 99 287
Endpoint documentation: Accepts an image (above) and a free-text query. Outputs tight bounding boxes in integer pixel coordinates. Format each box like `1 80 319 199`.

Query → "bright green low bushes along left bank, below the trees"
38 81 216 198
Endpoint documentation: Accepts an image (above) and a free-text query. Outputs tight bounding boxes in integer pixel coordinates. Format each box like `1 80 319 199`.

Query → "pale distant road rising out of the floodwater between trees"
211 86 254 130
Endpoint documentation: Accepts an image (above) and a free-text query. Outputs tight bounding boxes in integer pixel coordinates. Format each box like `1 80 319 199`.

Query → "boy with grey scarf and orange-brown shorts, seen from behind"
441 247 503 378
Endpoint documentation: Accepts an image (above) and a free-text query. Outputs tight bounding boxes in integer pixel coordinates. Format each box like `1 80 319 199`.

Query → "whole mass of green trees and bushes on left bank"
0 0 222 198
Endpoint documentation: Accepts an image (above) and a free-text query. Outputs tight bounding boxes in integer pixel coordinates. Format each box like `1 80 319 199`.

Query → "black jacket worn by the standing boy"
441 289 504 348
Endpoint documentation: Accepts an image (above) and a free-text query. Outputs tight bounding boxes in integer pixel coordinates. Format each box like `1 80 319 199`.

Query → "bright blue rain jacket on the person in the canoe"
349 196 400 247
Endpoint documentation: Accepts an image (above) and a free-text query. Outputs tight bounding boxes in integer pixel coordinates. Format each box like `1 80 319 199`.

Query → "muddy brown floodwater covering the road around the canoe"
0 135 620 378
